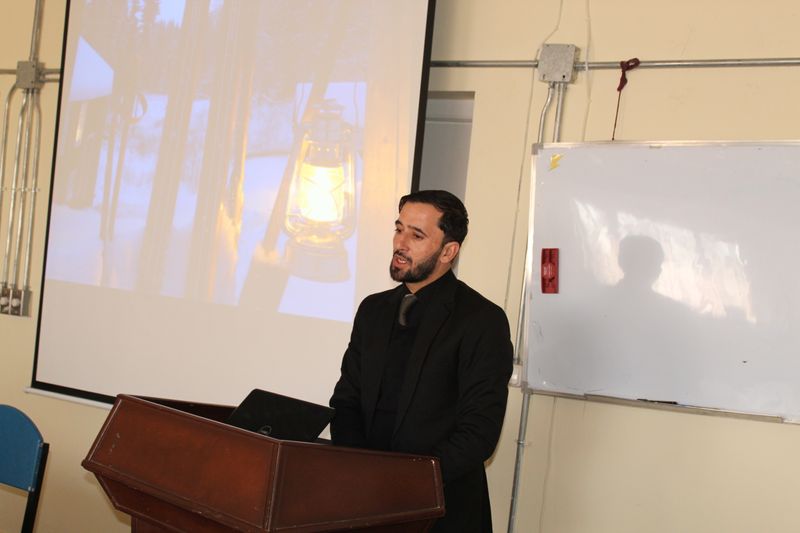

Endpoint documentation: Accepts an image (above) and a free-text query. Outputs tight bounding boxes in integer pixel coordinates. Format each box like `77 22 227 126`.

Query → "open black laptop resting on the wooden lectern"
226 389 334 442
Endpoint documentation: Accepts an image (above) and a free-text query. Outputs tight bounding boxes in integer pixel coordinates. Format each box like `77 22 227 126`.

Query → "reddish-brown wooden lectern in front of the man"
82 395 444 533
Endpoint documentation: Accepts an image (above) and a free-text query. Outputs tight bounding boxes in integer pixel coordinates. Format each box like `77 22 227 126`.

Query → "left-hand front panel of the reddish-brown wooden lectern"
86 398 276 526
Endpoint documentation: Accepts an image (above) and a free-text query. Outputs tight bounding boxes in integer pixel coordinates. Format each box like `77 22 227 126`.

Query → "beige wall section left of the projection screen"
0 4 130 533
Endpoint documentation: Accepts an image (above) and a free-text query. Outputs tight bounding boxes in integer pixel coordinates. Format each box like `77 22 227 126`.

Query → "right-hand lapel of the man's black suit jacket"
394 278 457 433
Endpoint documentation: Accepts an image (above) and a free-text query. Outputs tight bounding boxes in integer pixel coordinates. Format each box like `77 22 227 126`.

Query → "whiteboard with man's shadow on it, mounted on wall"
524 142 800 420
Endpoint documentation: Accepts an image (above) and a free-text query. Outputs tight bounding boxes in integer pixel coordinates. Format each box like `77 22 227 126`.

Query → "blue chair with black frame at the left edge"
0 405 50 533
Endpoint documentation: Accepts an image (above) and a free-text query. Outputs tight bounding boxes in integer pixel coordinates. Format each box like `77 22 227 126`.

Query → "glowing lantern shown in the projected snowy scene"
285 100 355 281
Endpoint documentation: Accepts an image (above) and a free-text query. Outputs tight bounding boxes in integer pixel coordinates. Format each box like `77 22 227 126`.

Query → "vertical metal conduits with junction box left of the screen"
0 0 60 316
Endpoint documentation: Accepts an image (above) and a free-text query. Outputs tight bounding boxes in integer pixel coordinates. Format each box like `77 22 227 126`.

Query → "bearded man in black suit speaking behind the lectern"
330 191 512 533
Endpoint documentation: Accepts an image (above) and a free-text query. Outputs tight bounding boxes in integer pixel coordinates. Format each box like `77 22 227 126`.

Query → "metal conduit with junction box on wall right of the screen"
438 44 800 533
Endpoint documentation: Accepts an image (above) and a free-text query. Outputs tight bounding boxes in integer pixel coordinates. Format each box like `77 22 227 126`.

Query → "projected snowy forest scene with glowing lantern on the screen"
47 0 382 321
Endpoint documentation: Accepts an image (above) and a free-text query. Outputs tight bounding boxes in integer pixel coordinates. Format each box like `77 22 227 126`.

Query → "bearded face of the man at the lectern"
389 202 458 291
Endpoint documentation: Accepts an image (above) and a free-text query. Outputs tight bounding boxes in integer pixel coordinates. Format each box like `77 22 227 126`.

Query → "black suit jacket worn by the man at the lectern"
330 273 513 533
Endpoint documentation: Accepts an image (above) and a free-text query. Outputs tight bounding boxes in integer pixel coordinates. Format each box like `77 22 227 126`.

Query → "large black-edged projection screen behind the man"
33 0 433 404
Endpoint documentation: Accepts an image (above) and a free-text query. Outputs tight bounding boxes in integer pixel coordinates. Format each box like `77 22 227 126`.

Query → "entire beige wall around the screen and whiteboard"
0 0 800 533
